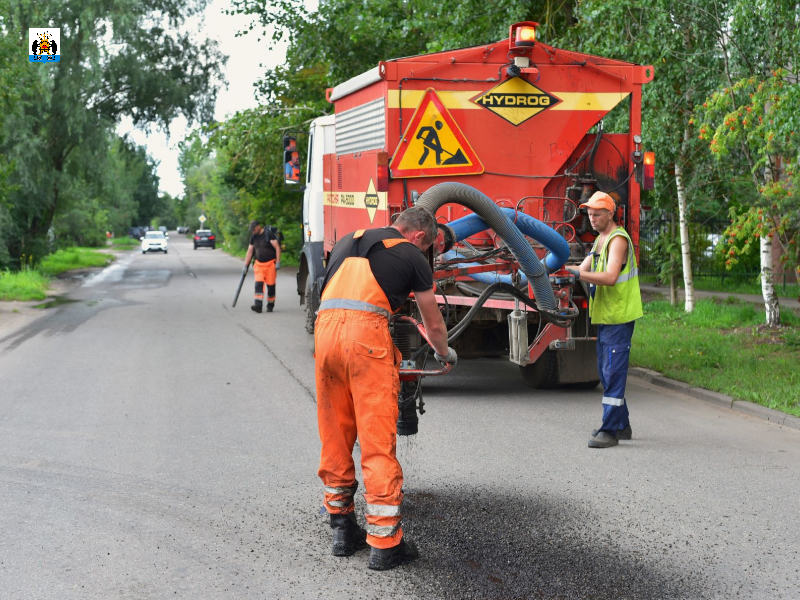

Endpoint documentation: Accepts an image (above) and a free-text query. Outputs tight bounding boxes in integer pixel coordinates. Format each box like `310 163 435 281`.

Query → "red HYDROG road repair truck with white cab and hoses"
290 22 654 433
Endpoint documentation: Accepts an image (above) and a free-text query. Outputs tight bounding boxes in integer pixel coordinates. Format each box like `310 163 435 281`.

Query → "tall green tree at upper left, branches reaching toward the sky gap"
4 0 224 262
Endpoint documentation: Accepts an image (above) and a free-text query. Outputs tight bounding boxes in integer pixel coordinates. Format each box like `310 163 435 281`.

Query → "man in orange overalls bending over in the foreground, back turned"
314 207 457 571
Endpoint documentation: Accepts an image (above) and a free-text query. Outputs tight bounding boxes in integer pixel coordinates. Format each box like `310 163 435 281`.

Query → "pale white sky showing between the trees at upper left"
117 0 294 196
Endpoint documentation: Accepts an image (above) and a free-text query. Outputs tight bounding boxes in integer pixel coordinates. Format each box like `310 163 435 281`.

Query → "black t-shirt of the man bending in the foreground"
323 227 433 310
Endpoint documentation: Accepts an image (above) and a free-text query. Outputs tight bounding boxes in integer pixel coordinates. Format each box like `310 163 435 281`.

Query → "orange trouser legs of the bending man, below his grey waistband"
314 309 403 548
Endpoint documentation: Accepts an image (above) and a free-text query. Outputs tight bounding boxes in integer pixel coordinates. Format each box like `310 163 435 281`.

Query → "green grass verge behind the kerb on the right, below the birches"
631 298 800 417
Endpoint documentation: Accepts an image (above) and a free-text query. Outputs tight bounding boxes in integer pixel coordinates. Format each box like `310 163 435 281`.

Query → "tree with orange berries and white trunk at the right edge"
698 0 800 326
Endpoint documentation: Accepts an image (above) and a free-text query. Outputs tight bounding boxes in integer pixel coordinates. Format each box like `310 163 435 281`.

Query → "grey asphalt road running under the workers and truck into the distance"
0 235 800 600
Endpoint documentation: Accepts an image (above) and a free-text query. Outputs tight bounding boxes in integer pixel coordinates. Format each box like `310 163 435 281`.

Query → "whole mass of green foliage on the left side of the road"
0 0 224 264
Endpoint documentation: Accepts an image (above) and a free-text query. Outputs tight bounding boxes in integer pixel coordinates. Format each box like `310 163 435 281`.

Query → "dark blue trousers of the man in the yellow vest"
597 321 635 435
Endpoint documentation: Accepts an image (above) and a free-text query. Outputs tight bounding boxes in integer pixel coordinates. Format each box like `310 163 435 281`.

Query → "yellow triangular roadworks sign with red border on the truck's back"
389 88 483 177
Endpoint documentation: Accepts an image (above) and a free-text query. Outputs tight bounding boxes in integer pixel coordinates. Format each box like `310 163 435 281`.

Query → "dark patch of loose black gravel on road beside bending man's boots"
403 489 710 600
